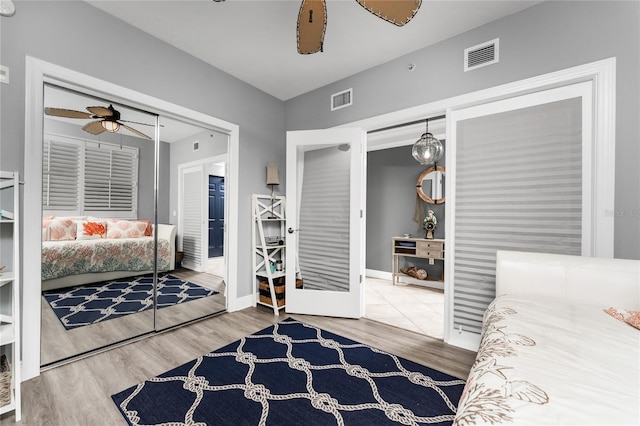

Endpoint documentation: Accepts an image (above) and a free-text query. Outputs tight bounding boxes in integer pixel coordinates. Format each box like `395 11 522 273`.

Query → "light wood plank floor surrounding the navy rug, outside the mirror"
0 307 475 426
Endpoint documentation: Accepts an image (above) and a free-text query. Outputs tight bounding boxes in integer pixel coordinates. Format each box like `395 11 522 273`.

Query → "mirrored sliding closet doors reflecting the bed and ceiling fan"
41 84 227 366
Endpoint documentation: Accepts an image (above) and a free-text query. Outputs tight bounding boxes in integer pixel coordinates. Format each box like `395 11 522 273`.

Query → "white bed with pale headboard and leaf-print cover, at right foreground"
454 251 640 426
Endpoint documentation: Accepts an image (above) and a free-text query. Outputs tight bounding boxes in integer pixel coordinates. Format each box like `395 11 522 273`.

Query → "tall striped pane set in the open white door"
298 144 351 291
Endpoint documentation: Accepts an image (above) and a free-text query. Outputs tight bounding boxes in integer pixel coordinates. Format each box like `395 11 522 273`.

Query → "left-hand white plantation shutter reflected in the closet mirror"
42 138 82 212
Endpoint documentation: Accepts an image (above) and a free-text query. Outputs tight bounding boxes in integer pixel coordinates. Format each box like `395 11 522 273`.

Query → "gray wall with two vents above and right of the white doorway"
285 1 640 259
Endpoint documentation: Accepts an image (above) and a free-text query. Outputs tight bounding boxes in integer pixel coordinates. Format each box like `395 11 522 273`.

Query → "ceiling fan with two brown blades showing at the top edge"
298 0 422 55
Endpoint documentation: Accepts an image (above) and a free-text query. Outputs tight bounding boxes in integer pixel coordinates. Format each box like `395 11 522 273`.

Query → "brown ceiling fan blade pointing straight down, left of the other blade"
297 0 327 55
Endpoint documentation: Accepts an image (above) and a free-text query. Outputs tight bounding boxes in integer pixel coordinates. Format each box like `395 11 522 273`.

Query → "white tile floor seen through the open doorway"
365 277 444 339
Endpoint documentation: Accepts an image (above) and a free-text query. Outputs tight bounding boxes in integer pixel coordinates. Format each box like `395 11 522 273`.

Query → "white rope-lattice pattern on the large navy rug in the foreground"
114 319 465 425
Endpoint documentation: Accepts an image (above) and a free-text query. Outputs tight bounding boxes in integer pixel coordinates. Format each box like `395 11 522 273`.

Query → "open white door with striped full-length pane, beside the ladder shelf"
285 129 366 318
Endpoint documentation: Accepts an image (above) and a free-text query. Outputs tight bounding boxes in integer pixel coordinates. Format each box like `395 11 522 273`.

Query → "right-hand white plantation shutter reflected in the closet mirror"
84 142 138 213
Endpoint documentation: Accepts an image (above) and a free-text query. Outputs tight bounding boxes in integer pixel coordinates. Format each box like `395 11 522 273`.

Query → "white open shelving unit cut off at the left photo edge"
0 171 22 422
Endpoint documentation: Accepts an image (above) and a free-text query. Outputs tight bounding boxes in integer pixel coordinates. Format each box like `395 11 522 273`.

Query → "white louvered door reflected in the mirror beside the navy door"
178 164 208 272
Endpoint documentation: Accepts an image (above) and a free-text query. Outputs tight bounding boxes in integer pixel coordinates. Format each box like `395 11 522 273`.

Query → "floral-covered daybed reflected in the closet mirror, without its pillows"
42 224 176 291
